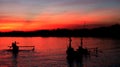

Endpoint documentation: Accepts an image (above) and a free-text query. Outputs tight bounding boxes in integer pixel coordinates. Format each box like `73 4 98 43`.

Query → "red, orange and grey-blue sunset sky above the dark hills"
0 0 120 31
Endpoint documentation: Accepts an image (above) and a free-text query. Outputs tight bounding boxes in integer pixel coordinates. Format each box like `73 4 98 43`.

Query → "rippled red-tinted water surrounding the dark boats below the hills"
0 37 120 67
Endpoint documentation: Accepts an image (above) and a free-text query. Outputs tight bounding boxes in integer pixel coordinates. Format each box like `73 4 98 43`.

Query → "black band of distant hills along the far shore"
0 24 120 38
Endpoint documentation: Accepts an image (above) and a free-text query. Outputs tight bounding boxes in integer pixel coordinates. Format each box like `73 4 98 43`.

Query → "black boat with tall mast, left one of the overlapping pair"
66 37 75 60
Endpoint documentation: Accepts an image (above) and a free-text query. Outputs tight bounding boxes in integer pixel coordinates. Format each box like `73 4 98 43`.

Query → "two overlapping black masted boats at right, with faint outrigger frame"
66 38 102 60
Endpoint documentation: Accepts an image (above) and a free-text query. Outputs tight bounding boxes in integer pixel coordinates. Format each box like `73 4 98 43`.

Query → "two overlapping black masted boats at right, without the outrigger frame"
66 37 90 60
